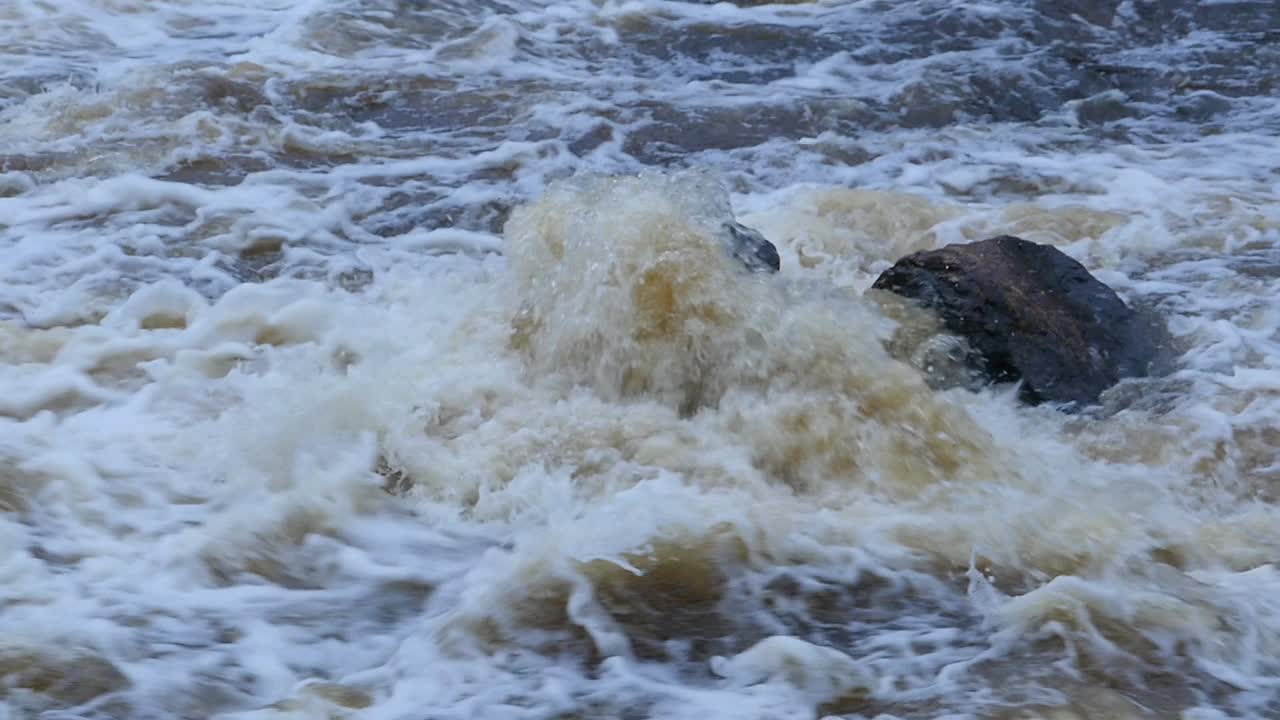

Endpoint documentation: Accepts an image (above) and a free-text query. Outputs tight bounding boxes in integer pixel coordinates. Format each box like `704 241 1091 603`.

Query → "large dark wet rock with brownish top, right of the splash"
873 236 1167 406
